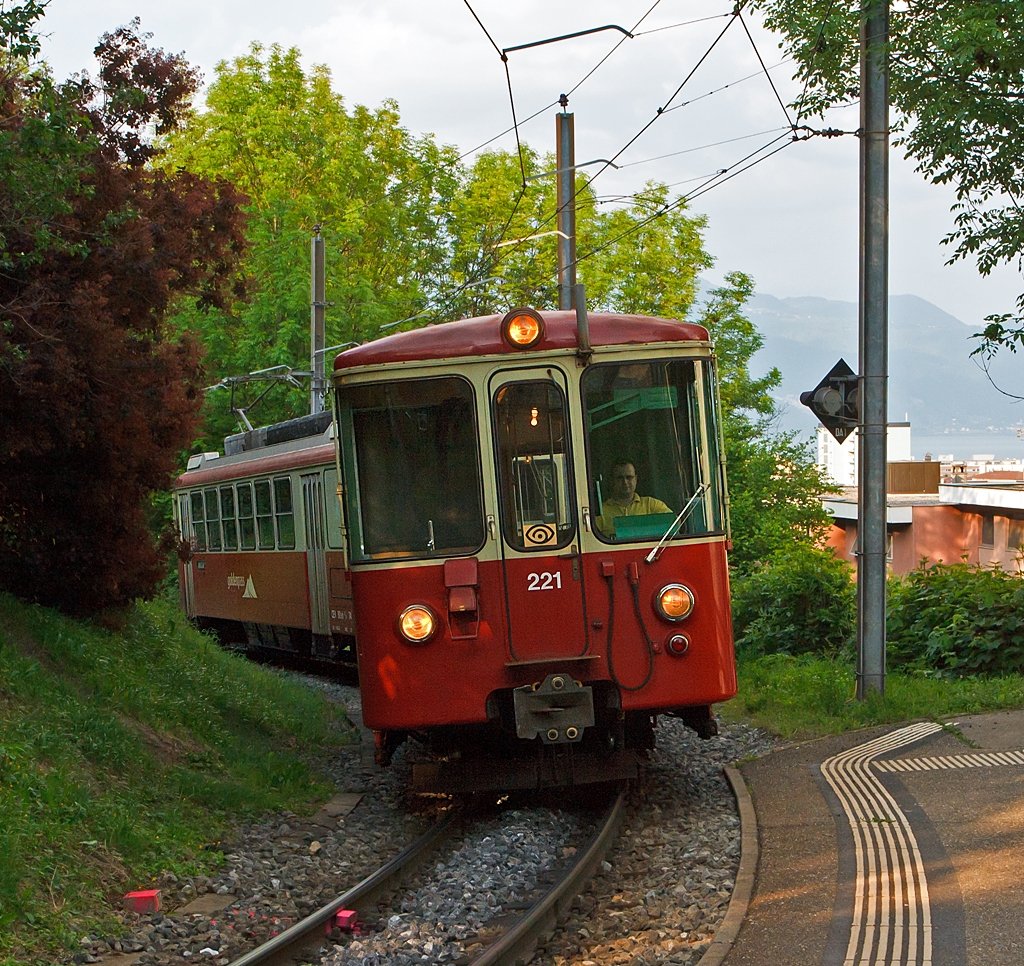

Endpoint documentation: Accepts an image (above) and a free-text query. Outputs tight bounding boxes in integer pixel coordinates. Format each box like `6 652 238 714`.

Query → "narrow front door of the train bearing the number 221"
488 368 587 663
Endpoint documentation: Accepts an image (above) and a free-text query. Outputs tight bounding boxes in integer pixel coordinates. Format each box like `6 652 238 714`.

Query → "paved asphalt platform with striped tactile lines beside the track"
724 711 1024 966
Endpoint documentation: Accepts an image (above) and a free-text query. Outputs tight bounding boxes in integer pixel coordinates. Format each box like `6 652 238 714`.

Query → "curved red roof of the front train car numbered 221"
334 311 709 372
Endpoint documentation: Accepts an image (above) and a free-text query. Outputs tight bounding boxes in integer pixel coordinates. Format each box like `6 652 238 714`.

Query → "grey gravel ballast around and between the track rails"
81 679 773 966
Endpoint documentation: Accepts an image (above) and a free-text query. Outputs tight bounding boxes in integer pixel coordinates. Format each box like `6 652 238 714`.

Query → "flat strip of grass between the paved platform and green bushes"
719 655 1024 739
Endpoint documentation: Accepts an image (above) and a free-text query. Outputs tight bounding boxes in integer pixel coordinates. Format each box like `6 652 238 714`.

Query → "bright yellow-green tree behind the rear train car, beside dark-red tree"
157 44 456 439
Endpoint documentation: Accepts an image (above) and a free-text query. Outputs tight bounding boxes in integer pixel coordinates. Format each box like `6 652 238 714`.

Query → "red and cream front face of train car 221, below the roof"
337 321 736 788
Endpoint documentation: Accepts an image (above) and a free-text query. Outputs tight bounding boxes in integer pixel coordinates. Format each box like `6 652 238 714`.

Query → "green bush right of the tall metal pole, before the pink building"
887 563 1024 677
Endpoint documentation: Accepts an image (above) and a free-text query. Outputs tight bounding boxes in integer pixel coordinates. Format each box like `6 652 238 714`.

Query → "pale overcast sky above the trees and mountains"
42 0 1024 327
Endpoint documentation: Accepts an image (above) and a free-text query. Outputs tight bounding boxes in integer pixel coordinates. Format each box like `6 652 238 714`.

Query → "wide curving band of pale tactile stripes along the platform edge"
821 722 946 966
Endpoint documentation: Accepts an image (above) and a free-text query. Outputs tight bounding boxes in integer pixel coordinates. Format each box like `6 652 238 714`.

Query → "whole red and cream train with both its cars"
176 309 736 790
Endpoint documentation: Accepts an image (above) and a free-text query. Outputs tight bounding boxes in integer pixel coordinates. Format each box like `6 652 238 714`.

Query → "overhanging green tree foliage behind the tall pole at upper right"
754 0 1024 372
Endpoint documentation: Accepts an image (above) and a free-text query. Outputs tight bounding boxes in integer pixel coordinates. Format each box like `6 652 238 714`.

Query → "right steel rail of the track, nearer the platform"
470 785 629 966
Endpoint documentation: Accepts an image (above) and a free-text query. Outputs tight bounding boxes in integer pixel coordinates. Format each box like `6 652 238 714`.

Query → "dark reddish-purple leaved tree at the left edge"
0 9 244 614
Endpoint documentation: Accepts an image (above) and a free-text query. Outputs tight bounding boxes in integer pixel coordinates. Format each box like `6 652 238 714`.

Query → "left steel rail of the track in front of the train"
231 809 462 966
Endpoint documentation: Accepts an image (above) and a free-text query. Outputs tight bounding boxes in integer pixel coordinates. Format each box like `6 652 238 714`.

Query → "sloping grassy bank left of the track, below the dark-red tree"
0 594 360 966
